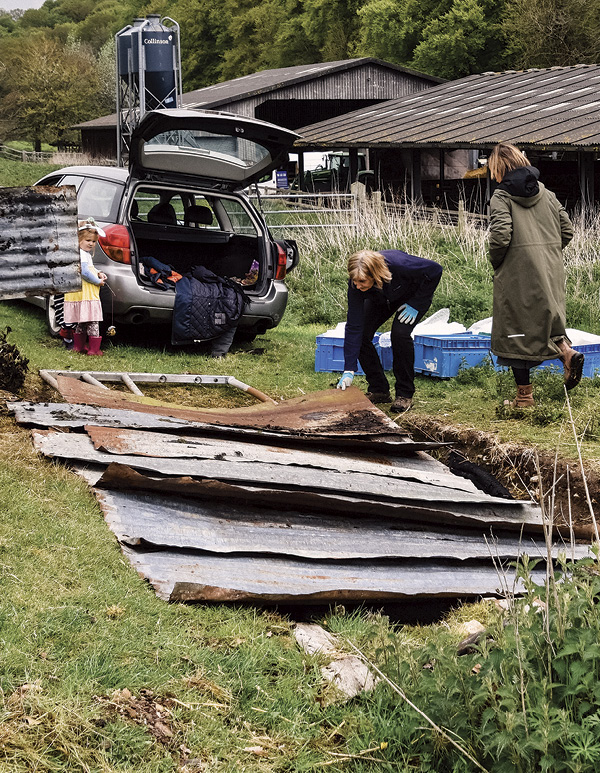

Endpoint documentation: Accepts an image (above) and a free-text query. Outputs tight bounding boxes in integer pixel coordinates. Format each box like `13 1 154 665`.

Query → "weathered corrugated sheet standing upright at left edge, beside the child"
0 187 81 300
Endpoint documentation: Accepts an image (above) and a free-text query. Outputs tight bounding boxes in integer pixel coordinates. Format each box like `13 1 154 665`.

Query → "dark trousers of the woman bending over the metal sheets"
358 298 423 397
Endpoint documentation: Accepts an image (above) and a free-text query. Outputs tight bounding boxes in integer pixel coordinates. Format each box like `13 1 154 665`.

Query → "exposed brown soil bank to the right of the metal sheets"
405 414 600 526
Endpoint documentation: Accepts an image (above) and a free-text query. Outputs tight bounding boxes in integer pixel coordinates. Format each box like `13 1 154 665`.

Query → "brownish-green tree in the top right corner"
503 0 600 68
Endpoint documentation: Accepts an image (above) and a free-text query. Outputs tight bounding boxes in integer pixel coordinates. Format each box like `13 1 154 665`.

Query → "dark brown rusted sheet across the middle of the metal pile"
96 462 564 541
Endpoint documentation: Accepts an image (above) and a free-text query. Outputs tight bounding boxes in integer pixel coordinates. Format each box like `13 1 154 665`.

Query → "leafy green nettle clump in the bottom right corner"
357 559 600 773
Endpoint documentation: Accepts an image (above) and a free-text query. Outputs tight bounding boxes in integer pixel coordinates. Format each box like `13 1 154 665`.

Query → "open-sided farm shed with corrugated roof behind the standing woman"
296 65 600 211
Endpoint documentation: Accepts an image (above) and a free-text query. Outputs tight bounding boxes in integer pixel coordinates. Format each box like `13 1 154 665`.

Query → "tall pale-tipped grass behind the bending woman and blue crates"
288 196 600 332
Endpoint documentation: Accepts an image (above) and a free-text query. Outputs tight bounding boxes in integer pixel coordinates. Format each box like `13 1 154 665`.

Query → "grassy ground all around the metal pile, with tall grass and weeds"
0 164 600 773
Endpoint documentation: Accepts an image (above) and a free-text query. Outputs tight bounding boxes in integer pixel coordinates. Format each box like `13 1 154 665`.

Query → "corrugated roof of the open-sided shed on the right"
296 65 600 150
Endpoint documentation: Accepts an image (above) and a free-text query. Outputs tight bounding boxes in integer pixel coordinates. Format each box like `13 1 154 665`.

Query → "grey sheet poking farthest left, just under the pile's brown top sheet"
7 401 452 455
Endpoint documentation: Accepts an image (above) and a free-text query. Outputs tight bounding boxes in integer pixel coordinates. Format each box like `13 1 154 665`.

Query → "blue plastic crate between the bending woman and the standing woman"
415 333 490 378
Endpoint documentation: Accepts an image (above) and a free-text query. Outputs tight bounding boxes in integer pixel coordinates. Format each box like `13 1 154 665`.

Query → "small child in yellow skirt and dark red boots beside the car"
64 217 106 355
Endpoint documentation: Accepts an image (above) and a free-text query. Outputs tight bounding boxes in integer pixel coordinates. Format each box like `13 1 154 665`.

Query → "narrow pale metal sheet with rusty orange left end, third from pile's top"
86 426 478 492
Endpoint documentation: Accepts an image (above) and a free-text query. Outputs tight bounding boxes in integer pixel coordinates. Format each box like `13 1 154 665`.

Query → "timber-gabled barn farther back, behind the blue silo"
72 57 443 163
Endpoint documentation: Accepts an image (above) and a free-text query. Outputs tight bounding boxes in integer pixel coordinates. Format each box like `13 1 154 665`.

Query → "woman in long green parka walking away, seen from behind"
488 143 584 408
